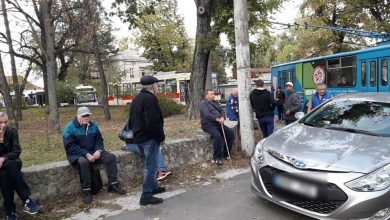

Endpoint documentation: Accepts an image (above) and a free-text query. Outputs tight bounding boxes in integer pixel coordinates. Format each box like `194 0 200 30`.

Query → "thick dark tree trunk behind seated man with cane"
186 0 213 119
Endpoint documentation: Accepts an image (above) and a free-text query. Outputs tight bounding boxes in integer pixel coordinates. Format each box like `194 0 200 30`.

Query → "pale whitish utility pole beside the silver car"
234 0 255 155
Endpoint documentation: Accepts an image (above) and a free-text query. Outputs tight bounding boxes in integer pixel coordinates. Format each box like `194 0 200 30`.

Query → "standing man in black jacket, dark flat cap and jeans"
130 76 166 205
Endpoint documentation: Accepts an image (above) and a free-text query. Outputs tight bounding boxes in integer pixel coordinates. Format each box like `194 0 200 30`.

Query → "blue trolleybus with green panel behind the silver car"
271 44 390 108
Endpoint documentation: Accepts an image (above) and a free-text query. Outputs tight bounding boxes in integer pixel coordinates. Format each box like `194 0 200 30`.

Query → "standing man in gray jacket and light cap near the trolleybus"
283 82 302 125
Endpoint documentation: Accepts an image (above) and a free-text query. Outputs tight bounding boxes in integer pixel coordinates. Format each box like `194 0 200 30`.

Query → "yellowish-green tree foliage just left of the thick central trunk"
112 0 192 71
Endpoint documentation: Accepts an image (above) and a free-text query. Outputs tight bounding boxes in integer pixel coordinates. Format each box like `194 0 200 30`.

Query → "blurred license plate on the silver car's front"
273 175 318 199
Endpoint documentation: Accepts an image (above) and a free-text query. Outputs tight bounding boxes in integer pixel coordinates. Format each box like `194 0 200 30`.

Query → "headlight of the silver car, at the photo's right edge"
345 164 390 192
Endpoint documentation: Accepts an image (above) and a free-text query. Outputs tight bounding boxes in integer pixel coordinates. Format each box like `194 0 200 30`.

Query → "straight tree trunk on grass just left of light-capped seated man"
41 0 60 133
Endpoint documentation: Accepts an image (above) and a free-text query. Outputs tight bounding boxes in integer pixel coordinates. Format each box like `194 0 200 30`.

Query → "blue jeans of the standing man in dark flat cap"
139 139 160 198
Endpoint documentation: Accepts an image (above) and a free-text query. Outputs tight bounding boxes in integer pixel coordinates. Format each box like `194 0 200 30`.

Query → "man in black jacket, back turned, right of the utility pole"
249 80 275 138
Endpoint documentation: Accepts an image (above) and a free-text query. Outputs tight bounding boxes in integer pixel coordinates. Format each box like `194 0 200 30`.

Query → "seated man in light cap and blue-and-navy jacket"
63 107 126 204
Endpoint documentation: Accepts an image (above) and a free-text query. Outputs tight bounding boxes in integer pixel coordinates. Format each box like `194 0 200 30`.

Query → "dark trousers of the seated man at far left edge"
0 159 31 215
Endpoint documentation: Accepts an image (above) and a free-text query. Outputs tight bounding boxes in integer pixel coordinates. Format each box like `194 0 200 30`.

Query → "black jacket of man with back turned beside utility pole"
249 89 276 118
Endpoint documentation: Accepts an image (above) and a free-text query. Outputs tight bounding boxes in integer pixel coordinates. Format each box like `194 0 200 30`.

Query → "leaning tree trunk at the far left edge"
1 0 23 121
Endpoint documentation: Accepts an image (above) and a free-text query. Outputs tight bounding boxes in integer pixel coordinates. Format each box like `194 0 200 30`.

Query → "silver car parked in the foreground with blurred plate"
251 93 390 220
